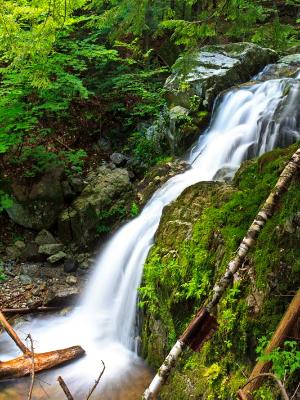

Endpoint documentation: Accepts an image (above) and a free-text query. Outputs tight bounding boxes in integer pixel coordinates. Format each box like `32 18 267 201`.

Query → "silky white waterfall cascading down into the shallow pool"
0 74 300 400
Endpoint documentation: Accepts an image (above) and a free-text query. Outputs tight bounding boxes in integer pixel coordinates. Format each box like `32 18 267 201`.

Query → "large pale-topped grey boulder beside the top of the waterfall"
165 43 277 110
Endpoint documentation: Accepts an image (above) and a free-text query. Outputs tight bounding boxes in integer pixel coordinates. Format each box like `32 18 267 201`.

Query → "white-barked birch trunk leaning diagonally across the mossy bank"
143 148 300 400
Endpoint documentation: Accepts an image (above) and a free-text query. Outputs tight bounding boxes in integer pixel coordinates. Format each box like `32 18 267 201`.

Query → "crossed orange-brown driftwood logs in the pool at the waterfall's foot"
0 312 85 380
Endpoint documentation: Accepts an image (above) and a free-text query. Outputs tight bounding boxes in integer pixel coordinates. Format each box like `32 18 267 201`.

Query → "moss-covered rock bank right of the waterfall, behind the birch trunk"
141 145 300 400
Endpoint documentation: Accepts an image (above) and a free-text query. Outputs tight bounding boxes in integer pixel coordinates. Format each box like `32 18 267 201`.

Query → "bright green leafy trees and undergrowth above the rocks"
0 0 298 200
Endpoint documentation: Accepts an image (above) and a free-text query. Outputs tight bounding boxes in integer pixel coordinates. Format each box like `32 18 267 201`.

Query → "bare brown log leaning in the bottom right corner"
238 290 300 400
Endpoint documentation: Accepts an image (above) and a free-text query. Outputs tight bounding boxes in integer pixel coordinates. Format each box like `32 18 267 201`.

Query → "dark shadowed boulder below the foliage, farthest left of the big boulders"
7 168 64 230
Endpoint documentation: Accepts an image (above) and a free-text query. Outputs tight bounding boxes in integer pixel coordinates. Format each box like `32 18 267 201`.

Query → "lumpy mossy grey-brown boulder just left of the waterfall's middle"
58 166 133 244
